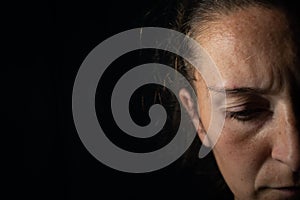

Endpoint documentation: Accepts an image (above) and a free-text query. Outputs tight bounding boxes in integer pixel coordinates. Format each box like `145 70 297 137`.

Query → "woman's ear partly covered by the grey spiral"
179 88 210 146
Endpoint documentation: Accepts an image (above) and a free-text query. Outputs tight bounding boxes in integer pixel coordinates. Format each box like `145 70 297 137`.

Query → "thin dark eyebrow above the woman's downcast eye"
208 87 270 95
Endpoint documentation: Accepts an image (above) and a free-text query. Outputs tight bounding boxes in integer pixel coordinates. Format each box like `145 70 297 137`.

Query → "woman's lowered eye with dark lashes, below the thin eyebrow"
226 109 270 122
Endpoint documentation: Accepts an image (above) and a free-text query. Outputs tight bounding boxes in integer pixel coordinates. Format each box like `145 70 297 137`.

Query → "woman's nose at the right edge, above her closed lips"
272 104 300 172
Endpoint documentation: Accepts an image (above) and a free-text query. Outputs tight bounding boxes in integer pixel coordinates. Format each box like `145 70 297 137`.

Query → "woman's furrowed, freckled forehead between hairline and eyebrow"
199 7 294 88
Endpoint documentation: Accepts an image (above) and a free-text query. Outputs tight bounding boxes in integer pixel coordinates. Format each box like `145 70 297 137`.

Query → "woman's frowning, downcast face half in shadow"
195 7 300 200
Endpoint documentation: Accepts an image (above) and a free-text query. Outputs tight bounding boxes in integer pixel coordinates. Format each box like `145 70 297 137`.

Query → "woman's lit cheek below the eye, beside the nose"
213 126 268 198
